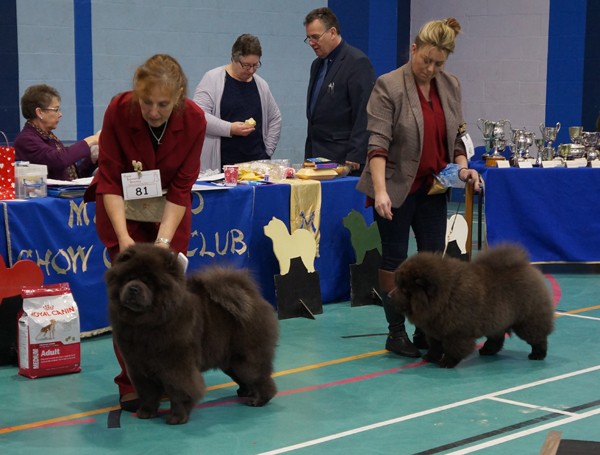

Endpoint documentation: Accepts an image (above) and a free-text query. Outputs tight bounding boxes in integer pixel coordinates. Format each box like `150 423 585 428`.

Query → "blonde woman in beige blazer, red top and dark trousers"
357 18 479 357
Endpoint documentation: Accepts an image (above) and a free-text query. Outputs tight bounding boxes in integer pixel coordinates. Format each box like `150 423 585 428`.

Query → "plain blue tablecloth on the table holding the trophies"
470 162 600 263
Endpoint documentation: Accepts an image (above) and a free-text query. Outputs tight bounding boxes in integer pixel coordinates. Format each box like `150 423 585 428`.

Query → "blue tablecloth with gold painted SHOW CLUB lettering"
0 177 373 331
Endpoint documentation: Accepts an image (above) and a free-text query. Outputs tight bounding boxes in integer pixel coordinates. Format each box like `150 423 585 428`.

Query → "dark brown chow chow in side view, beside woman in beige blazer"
390 245 554 368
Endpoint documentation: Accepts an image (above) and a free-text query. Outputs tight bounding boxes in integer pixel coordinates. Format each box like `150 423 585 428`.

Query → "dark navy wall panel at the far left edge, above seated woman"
0 0 21 145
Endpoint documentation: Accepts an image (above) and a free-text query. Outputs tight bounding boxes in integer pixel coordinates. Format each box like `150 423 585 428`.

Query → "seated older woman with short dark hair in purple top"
13 84 99 180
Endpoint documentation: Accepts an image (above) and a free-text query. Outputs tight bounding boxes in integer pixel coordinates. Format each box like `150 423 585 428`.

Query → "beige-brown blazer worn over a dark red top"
356 62 465 207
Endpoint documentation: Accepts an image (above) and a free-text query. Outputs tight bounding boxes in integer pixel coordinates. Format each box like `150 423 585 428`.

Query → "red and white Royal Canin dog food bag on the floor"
18 283 81 379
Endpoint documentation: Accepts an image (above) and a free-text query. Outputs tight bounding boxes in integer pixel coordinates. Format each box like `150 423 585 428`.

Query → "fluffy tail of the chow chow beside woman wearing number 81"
188 267 269 321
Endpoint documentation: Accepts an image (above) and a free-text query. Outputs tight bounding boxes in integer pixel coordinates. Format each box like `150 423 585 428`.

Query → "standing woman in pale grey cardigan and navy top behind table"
194 34 281 171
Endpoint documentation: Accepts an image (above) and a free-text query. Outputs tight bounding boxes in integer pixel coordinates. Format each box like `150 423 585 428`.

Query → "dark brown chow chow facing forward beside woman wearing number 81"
105 244 279 424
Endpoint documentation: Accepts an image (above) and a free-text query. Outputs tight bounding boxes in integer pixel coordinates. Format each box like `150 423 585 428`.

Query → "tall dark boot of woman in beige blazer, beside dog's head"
379 269 421 357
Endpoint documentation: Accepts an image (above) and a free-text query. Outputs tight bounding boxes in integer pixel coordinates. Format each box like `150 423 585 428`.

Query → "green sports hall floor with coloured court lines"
0 206 600 455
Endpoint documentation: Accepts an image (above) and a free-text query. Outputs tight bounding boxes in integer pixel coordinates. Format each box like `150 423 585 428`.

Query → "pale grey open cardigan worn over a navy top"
194 66 281 171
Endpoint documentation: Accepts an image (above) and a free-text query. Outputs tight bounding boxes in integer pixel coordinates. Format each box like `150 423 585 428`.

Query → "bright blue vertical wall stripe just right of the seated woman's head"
73 0 94 140
